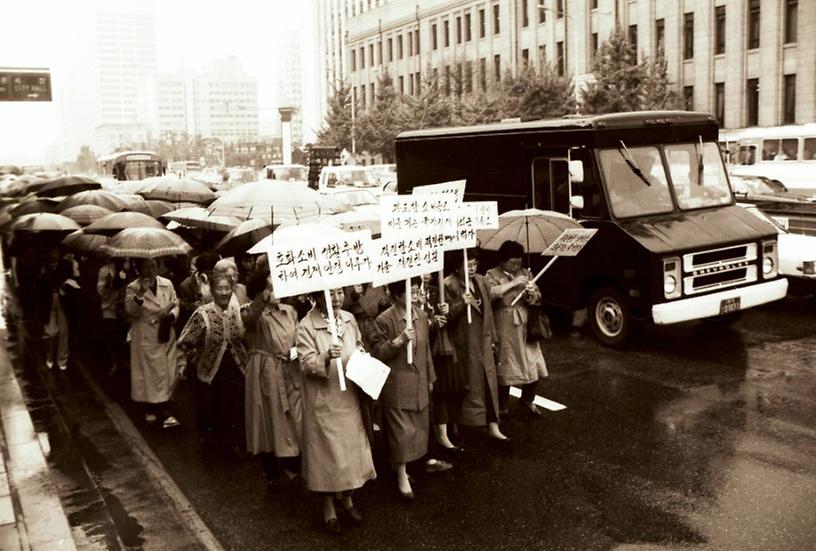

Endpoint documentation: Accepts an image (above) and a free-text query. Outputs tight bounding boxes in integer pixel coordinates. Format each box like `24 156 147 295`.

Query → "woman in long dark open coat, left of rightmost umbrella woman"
444 249 509 442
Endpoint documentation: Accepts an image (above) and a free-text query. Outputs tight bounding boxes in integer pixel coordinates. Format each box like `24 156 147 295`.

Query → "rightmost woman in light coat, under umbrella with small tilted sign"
485 241 544 416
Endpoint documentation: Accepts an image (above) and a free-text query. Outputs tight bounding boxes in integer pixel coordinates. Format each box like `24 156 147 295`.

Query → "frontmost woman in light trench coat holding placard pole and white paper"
296 289 377 534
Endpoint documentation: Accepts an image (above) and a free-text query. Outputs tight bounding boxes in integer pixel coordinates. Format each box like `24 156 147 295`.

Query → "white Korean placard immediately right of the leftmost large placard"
372 233 444 286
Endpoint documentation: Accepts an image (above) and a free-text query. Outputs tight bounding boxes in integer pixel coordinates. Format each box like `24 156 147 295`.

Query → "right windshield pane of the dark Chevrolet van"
664 142 731 210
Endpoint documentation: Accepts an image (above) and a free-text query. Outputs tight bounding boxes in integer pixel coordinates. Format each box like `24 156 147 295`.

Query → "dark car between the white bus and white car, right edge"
730 174 816 236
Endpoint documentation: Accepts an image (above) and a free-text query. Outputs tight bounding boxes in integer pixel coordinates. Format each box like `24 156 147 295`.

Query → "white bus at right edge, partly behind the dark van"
720 123 816 192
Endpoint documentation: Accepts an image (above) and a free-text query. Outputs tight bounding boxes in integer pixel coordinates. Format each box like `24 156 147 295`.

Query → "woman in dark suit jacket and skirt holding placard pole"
372 278 436 499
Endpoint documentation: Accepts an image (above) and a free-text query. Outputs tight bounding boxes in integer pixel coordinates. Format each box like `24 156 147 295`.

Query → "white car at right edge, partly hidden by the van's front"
737 203 816 295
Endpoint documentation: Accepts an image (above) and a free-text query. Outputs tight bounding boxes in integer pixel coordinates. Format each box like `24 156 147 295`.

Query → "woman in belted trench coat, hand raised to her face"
241 272 303 489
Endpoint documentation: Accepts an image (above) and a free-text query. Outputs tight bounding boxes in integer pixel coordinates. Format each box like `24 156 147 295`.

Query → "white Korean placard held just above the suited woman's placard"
380 195 458 236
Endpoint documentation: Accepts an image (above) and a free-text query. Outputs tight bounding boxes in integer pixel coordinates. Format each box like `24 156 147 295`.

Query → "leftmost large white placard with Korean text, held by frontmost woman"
268 230 376 298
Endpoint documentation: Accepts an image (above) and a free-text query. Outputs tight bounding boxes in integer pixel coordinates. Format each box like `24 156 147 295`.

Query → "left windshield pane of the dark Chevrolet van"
599 146 674 218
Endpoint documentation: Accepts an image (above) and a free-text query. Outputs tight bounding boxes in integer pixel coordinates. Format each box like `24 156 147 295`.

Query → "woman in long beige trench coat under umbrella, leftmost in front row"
125 258 179 428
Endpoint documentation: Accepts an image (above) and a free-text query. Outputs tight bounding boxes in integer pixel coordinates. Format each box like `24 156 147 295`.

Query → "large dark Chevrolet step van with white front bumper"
395 111 787 347
